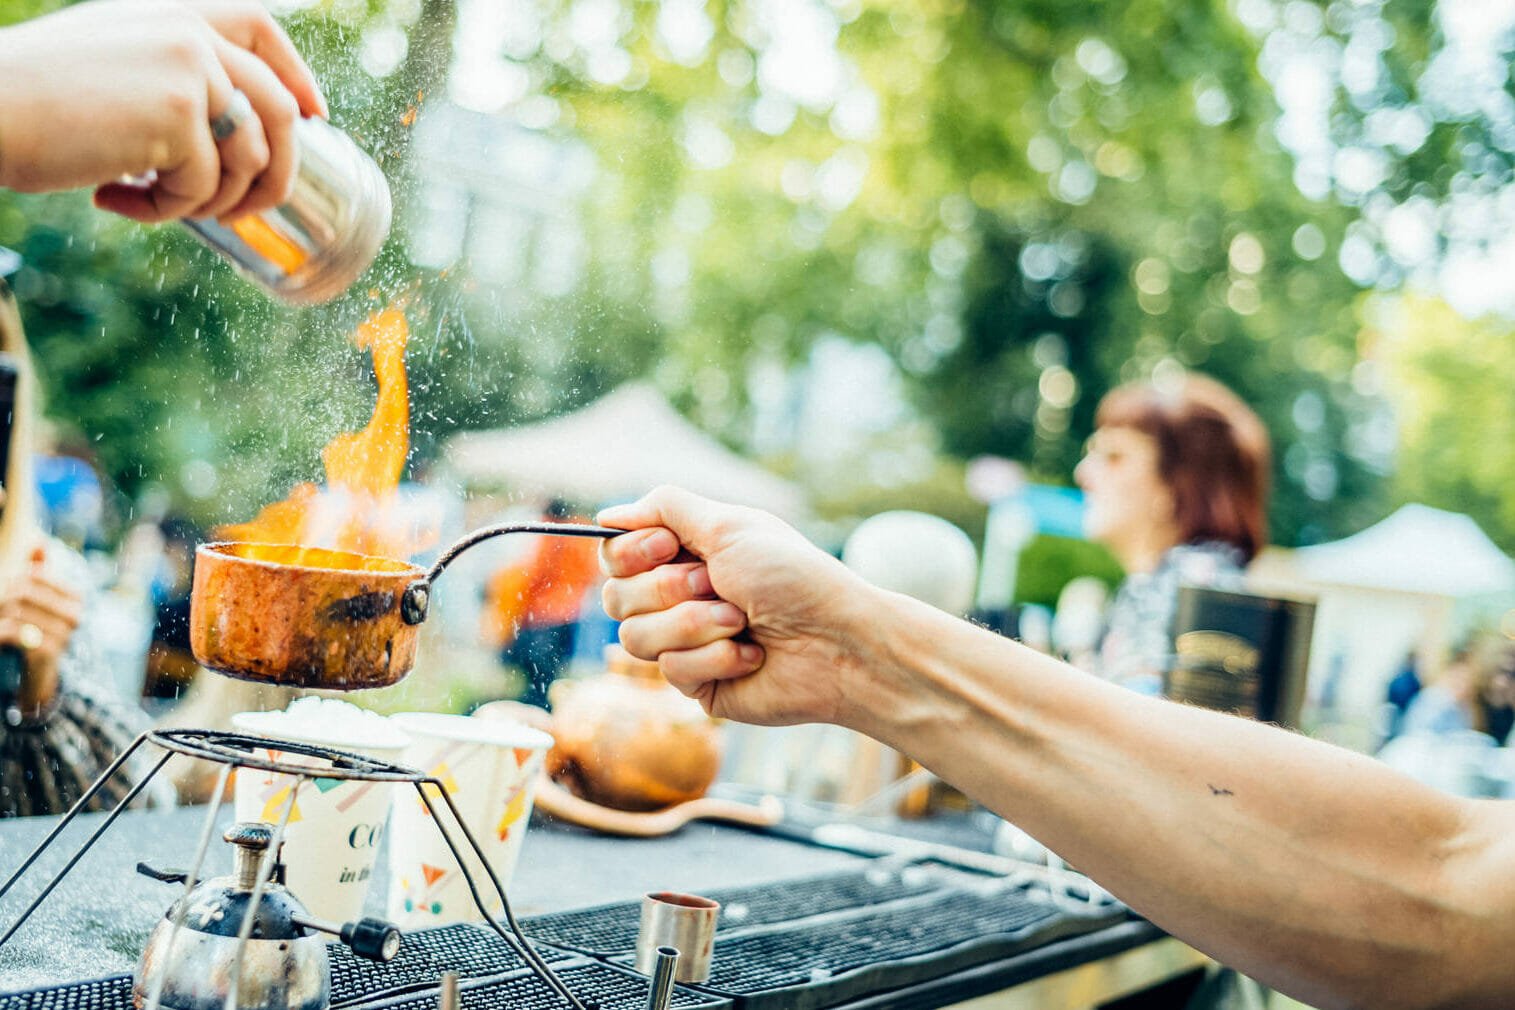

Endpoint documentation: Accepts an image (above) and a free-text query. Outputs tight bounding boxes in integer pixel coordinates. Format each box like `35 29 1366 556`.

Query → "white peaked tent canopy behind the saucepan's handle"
442 383 804 519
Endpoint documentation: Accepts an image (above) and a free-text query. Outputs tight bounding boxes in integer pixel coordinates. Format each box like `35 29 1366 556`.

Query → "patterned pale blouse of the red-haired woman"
1095 541 1244 695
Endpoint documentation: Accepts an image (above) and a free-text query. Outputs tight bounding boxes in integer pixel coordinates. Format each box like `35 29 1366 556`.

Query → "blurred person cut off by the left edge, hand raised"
0 268 168 816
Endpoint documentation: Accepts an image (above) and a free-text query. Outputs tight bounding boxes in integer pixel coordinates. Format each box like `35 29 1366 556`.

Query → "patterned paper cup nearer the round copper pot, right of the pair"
389 712 553 928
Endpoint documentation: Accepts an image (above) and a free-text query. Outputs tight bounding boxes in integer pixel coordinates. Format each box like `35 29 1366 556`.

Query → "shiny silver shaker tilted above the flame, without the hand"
185 118 391 304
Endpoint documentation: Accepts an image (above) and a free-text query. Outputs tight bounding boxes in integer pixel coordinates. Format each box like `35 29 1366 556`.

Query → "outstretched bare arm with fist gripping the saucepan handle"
600 489 1515 1008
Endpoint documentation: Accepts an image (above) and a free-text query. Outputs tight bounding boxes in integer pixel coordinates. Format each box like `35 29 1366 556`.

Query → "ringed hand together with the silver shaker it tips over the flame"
0 0 391 303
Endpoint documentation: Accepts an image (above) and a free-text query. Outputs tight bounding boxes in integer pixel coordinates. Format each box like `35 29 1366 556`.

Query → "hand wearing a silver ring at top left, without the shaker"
0 0 327 211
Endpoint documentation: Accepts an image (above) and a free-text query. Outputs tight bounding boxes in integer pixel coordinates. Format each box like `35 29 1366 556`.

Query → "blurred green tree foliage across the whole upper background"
0 0 1510 554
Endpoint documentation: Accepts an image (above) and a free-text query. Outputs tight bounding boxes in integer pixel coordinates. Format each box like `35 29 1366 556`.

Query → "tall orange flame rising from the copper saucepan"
215 306 435 557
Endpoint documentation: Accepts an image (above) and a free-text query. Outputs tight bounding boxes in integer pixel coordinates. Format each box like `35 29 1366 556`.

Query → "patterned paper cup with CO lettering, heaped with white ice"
232 698 411 922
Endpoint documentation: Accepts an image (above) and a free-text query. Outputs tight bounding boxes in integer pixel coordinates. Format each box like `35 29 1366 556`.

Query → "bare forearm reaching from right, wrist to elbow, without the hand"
847 597 1515 1007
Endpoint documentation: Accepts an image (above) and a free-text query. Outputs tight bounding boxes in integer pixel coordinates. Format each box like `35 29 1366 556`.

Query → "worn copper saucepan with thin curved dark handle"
189 522 624 690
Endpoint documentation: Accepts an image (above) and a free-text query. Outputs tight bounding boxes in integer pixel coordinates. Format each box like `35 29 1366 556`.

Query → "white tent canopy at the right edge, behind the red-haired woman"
1297 504 1515 600
